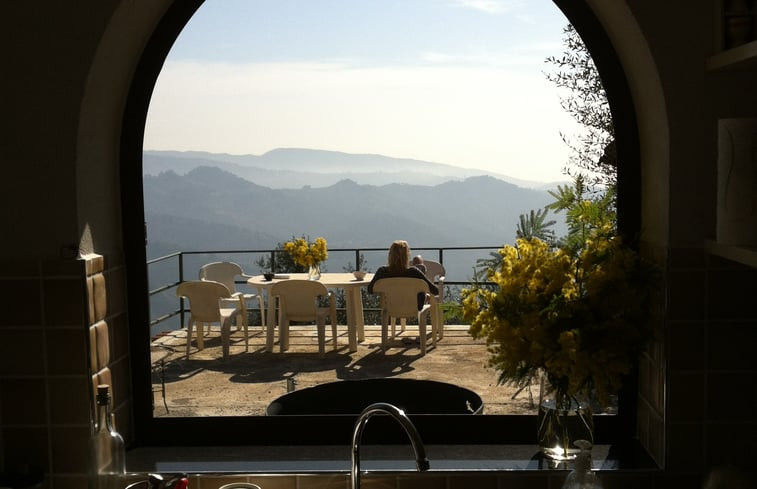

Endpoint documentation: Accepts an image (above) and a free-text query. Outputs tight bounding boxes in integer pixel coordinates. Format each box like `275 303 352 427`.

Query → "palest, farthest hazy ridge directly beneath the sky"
143 148 555 189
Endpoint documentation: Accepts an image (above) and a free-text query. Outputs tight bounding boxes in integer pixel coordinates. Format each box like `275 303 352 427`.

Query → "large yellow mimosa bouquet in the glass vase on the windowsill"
462 234 652 408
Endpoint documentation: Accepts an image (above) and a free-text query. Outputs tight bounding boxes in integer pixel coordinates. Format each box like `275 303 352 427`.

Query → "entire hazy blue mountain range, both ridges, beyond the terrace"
143 150 564 328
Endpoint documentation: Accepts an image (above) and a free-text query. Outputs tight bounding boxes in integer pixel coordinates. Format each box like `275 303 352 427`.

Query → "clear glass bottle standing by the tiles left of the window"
91 384 126 489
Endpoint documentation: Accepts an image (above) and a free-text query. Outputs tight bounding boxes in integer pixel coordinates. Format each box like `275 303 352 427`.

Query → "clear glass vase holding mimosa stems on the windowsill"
538 378 594 461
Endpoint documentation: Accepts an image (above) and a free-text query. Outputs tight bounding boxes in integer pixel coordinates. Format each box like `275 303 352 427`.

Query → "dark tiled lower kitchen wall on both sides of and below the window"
0 248 757 489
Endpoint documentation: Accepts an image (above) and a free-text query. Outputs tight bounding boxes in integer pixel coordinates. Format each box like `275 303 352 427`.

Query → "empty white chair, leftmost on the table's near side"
176 280 250 359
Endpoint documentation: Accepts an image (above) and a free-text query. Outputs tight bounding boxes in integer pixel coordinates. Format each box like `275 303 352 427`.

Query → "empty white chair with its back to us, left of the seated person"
268 279 336 356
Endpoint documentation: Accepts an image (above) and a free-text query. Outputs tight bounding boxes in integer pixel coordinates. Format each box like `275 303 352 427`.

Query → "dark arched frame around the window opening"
121 0 640 445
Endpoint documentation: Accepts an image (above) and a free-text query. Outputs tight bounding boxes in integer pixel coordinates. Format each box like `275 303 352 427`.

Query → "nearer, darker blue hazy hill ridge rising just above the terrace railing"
144 166 552 256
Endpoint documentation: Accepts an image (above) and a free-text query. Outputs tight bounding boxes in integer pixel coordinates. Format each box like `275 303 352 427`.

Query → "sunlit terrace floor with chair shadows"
152 325 538 416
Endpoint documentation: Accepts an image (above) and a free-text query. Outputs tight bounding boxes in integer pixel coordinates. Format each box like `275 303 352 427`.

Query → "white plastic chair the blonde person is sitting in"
373 277 439 355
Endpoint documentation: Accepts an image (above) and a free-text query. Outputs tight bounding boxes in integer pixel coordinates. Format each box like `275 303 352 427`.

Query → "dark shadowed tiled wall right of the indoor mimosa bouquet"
656 248 757 473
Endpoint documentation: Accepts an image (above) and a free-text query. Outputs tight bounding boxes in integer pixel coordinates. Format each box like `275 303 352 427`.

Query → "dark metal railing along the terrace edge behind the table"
147 245 502 330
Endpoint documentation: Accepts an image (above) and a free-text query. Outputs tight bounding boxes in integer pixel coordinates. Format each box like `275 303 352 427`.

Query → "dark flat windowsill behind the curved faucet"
127 445 658 474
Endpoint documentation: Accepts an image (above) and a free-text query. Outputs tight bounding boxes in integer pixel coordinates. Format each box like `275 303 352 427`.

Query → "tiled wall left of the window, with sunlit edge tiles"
0 255 131 489
